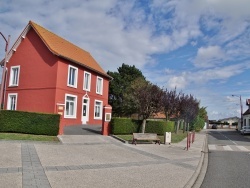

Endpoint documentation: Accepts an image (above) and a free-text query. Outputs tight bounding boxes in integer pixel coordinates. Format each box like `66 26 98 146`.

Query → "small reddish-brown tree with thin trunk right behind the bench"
134 82 164 133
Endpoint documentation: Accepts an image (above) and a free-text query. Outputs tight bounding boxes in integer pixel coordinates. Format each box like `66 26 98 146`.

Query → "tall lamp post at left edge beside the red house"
0 32 10 110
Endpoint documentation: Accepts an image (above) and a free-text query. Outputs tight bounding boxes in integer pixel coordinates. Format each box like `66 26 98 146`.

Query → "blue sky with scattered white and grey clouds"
0 0 250 120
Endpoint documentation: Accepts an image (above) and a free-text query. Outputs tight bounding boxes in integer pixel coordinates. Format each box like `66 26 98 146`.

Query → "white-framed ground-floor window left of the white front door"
64 94 77 118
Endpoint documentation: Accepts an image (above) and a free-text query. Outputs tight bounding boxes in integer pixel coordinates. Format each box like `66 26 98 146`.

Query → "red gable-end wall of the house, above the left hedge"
5 29 57 113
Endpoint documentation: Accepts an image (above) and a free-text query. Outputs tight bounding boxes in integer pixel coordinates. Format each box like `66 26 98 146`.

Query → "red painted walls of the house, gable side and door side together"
5 26 109 129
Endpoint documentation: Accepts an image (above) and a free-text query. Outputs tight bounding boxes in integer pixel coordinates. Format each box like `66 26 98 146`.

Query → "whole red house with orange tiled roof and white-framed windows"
1 21 111 133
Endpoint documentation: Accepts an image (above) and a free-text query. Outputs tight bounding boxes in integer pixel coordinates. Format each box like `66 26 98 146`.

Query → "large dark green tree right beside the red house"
108 64 145 116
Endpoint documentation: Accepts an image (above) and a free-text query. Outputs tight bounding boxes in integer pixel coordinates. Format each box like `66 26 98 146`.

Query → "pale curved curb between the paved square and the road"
184 133 208 188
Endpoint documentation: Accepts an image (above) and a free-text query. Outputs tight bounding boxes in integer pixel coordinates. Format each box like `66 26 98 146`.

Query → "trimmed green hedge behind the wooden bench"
111 118 175 135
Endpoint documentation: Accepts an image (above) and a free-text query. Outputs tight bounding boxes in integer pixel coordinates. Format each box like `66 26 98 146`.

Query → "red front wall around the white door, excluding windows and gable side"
56 59 109 125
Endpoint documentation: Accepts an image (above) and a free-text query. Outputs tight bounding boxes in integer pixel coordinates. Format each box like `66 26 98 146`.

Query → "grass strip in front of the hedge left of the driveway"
0 133 59 142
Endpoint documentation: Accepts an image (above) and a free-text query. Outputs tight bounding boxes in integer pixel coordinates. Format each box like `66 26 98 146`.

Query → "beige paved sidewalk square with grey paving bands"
0 132 206 188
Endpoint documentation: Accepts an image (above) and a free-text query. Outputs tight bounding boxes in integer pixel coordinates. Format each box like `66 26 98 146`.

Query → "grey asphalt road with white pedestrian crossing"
201 129 250 188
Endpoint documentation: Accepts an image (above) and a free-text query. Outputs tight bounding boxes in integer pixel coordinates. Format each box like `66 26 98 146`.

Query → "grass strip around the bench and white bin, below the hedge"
115 131 187 143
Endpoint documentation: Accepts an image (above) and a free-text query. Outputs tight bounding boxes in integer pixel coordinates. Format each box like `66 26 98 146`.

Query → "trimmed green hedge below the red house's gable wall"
0 110 60 136
